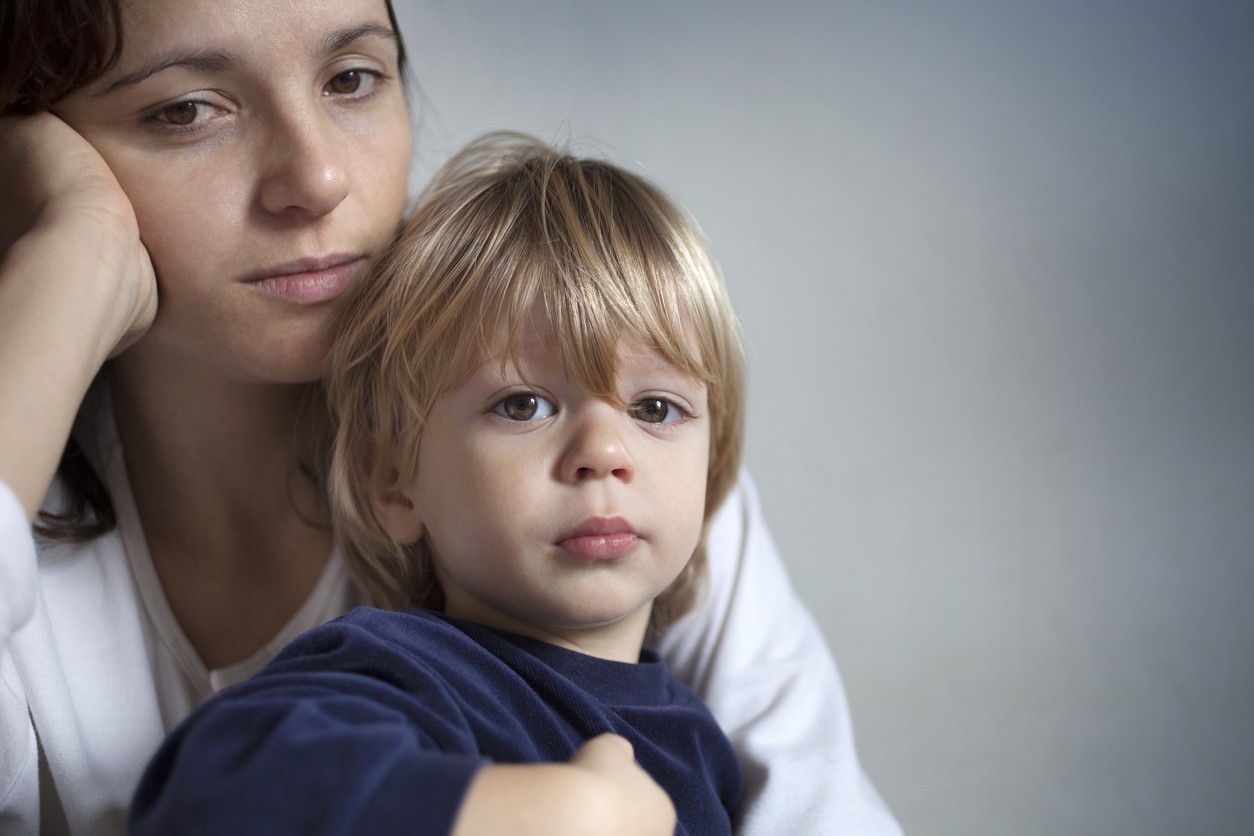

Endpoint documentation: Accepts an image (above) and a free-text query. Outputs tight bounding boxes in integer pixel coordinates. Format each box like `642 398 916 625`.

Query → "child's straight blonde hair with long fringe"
326 133 744 628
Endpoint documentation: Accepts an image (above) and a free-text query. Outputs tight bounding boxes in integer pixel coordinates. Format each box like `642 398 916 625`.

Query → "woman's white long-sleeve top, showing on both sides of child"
0 396 900 836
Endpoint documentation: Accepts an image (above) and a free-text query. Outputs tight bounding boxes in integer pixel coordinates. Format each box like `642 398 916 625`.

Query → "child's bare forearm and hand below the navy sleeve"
453 734 675 836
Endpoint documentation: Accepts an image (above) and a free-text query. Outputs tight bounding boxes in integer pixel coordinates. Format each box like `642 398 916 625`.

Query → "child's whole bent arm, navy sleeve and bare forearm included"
129 634 676 836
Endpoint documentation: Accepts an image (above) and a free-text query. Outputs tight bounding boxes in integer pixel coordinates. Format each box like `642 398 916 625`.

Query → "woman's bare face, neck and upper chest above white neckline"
50 0 410 667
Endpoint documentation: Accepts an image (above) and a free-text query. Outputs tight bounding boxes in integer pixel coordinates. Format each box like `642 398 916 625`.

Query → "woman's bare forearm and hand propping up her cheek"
0 113 157 519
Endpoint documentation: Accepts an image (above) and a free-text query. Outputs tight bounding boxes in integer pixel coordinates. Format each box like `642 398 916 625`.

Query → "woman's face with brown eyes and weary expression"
58 0 410 382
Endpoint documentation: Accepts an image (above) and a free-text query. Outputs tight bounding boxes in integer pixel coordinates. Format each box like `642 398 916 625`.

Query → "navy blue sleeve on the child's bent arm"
128 625 483 836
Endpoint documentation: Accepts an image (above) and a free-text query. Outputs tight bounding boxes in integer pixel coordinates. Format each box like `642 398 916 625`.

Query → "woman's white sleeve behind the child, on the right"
660 473 900 836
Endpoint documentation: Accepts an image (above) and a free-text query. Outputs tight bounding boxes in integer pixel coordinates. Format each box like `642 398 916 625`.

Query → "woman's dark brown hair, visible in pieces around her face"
0 0 408 541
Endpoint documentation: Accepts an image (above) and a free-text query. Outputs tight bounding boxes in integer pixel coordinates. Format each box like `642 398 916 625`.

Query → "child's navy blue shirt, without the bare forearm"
130 608 741 836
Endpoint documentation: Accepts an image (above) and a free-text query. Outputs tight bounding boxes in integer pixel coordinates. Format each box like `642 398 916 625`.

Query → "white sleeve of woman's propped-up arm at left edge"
0 473 39 833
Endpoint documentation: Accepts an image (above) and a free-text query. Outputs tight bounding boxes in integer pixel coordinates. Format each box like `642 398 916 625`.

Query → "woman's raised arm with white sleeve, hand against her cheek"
0 114 157 832
